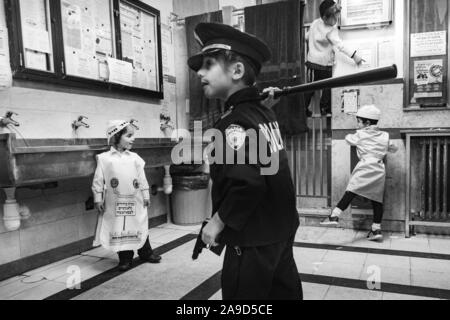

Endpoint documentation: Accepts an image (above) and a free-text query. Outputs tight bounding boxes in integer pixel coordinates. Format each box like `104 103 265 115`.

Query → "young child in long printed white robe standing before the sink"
92 120 161 271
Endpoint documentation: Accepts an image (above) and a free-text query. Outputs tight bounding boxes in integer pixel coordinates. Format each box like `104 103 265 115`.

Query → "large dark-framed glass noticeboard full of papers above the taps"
5 0 164 100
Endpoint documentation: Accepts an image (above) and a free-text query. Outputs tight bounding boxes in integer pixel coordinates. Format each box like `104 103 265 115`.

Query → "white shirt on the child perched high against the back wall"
306 18 355 66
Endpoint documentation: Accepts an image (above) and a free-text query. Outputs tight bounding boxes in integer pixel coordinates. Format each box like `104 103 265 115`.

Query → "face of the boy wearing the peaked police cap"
197 56 233 100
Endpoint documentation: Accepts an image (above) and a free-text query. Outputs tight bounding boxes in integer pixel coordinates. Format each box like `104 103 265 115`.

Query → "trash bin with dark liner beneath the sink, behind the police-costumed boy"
172 172 211 226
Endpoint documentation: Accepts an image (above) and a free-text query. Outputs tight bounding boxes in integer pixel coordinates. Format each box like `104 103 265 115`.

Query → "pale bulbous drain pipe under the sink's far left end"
3 188 31 231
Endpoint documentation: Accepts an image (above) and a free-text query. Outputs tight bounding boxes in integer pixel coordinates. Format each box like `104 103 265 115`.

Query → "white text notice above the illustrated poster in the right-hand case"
411 31 447 57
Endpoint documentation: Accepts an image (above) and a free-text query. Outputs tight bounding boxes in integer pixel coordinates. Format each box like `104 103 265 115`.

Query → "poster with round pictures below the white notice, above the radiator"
414 59 445 99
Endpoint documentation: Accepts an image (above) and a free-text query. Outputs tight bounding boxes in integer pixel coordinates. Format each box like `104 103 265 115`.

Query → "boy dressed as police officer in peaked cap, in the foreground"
188 23 302 300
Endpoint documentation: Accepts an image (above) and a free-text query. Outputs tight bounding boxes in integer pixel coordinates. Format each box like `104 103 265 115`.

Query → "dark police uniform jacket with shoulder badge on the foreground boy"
210 87 299 247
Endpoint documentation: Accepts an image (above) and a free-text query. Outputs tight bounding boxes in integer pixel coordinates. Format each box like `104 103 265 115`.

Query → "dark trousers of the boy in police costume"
222 238 303 300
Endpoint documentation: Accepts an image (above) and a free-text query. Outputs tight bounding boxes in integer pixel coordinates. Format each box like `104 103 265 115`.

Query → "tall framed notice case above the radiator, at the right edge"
405 0 450 110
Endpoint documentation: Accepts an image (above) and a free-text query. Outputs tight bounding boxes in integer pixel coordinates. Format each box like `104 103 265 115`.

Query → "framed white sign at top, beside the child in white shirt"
339 0 393 29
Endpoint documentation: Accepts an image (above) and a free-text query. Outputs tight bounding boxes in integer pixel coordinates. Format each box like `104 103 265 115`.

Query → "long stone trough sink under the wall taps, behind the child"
0 133 179 188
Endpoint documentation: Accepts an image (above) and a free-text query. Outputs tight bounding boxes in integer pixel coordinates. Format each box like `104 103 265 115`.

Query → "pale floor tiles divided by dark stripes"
0 224 450 300
